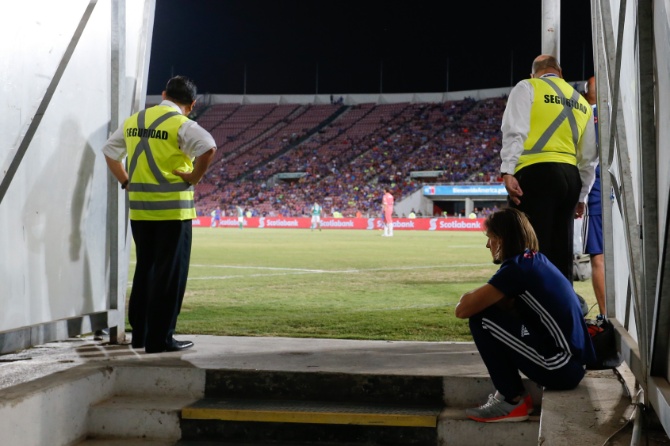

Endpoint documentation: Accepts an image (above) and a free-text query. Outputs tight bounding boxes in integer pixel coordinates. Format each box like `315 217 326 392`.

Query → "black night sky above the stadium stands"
148 0 593 94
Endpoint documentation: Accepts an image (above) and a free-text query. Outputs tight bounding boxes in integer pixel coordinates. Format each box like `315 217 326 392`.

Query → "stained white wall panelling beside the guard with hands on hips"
0 0 153 332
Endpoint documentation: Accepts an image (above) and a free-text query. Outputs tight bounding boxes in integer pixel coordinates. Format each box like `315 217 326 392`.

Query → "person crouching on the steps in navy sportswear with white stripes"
456 208 595 422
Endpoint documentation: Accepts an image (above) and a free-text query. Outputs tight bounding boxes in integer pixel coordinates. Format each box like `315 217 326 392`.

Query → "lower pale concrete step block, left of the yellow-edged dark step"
88 395 196 441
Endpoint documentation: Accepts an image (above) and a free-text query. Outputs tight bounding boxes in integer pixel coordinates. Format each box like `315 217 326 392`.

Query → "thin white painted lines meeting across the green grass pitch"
188 263 490 281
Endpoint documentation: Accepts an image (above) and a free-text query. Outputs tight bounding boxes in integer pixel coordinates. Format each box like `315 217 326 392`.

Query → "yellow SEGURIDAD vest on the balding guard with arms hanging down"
514 77 592 173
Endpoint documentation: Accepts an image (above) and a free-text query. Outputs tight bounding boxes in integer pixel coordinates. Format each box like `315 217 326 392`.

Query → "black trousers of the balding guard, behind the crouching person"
509 163 582 283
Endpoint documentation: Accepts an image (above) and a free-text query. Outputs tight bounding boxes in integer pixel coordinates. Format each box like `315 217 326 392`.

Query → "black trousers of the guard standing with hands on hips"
128 220 193 351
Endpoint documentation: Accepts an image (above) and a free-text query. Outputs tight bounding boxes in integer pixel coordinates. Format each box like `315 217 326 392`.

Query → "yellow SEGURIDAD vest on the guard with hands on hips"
123 105 196 220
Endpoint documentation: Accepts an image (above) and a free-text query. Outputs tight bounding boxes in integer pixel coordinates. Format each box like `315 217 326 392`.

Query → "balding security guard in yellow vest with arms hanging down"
500 55 598 281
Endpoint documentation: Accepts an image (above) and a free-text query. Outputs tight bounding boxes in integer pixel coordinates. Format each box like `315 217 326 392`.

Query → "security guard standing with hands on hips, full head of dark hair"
103 76 216 353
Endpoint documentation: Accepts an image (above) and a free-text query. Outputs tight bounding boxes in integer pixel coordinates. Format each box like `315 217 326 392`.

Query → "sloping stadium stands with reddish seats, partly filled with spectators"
186 96 506 216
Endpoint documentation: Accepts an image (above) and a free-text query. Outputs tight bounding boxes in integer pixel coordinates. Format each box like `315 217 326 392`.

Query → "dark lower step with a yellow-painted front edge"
181 398 443 446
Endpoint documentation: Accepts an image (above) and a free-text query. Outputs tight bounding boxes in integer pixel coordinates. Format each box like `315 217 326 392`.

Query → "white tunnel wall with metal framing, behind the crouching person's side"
592 0 670 432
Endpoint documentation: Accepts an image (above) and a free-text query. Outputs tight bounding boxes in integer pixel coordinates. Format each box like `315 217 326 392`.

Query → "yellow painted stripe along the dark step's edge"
181 407 437 428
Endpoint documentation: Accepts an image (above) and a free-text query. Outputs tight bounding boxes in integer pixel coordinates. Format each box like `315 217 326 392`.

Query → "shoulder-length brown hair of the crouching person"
484 207 539 261
